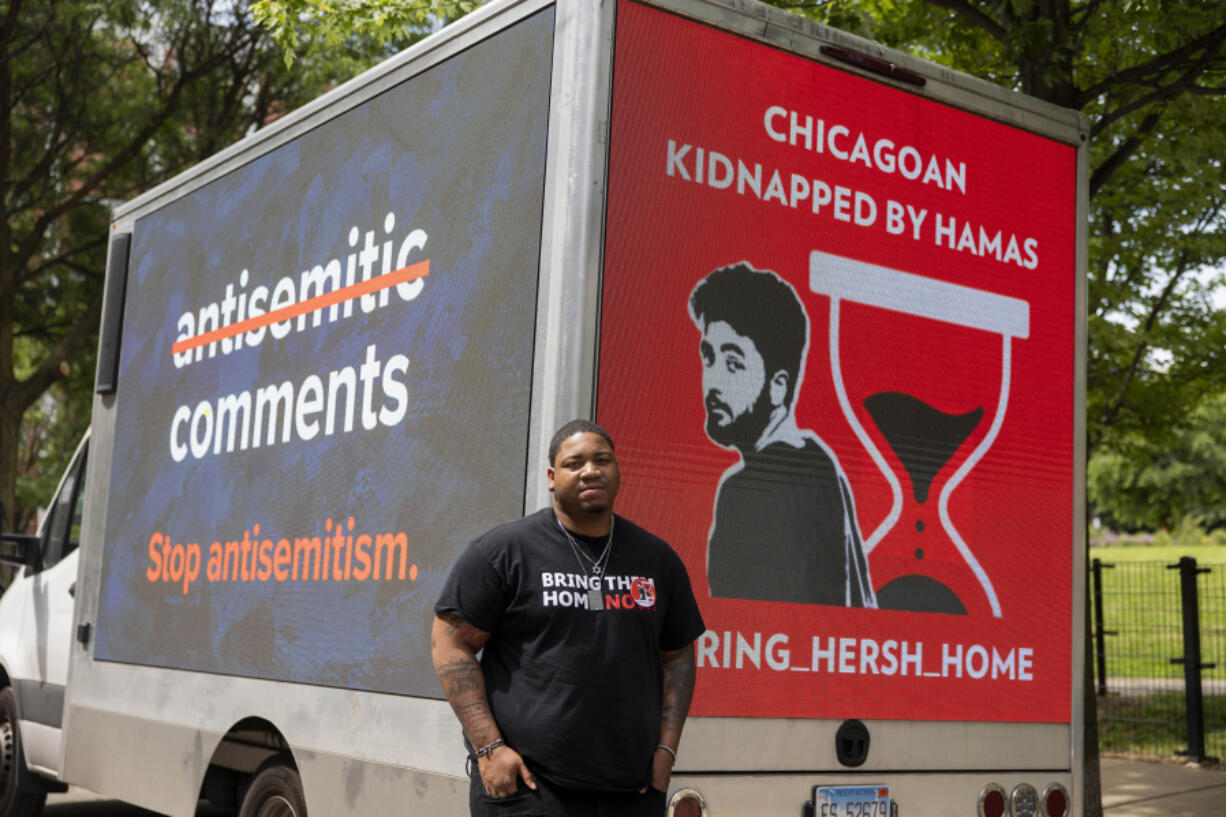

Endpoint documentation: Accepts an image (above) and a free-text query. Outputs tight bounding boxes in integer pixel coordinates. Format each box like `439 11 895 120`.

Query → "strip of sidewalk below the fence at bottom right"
1100 757 1226 817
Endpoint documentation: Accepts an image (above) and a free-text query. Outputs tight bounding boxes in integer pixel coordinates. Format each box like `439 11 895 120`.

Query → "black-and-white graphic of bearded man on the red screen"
689 263 877 607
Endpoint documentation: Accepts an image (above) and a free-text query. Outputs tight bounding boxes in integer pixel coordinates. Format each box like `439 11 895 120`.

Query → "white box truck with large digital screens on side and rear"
0 0 1087 817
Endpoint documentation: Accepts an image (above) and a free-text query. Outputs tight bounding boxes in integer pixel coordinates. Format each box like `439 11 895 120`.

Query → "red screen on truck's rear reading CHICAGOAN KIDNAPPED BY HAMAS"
597 0 1076 723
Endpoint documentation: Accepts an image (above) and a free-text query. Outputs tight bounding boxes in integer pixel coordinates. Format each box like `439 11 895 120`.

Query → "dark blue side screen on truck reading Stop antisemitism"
94 10 553 696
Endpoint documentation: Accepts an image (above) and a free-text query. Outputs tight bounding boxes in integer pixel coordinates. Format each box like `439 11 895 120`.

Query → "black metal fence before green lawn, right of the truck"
1090 557 1226 761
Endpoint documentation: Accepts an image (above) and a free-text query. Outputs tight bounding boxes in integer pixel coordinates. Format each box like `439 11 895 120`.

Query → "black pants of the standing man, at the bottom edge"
468 763 667 817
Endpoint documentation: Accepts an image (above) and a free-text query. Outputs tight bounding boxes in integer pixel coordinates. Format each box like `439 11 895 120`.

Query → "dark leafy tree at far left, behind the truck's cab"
0 0 384 529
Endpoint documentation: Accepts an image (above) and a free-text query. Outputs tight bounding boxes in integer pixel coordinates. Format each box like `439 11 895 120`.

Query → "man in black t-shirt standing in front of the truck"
430 420 704 817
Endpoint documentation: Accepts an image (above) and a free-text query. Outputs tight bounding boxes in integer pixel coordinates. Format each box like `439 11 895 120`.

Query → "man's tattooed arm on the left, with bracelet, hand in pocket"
430 612 536 797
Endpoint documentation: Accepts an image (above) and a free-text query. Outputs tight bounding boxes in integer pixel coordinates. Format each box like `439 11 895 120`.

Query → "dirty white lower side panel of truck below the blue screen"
66 662 467 817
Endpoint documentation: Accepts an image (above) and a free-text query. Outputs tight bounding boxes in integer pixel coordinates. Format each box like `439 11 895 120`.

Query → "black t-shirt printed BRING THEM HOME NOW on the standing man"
434 508 704 791
